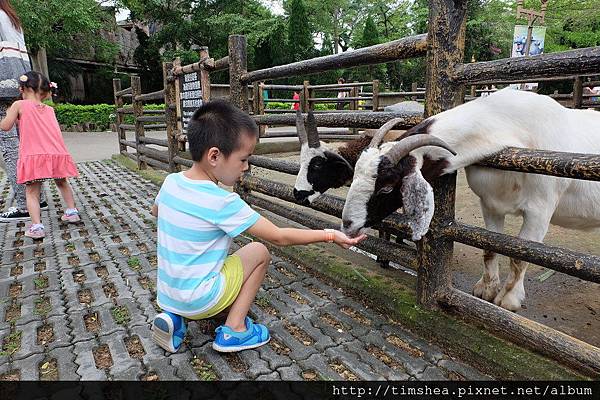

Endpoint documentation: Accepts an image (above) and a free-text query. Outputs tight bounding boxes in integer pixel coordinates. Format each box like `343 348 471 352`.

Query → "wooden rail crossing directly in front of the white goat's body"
479 147 600 181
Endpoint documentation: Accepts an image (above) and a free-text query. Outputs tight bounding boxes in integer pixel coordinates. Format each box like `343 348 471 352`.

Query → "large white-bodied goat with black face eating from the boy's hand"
342 89 600 311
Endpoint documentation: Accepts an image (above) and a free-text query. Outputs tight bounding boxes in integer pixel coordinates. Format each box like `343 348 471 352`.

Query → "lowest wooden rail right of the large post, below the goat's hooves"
439 288 600 377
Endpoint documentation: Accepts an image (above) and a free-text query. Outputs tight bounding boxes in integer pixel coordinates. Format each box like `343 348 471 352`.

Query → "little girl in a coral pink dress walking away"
0 71 80 239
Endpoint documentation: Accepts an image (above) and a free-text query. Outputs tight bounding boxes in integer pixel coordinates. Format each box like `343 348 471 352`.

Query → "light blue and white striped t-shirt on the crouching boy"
155 172 260 317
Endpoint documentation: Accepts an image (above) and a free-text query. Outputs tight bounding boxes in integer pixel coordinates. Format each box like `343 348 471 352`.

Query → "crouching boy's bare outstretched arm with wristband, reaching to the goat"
247 217 366 249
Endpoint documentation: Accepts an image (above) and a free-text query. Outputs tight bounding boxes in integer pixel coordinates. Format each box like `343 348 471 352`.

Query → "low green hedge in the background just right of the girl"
49 103 165 131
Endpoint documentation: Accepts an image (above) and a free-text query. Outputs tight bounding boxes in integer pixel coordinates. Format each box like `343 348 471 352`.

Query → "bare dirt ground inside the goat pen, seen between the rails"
253 148 600 347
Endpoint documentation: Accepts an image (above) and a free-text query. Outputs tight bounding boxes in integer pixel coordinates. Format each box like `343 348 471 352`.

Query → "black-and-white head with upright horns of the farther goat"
294 111 353 204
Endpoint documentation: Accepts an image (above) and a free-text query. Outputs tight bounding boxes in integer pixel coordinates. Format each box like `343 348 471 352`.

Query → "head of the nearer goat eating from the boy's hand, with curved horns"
342 119 455 240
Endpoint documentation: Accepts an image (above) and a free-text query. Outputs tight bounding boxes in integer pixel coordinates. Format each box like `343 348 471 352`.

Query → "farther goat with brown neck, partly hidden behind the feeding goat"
294 111 404 204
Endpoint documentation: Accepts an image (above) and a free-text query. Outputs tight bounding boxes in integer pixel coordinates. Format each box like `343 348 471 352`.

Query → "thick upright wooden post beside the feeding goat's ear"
417 0 467 308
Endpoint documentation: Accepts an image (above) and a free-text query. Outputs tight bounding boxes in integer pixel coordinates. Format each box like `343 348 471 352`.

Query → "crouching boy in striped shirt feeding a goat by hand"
152 100 364 352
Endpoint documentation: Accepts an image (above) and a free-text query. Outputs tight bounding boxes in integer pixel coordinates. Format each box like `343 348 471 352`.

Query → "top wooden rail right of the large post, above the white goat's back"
454 46 600 84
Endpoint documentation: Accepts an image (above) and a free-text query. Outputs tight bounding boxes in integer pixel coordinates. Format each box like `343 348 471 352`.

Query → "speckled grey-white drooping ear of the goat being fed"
402 168 435 240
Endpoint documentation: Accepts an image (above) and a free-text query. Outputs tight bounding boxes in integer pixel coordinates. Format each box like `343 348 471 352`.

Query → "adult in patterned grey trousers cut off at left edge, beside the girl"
0 0 48 222
